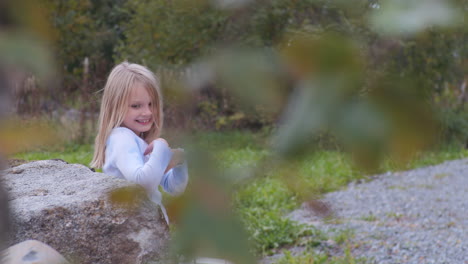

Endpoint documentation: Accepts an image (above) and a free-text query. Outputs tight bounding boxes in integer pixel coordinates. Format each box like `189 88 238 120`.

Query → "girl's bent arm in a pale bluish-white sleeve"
112 131 172 190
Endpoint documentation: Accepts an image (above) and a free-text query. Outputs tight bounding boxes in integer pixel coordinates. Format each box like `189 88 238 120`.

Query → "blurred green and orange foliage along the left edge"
0 1 53 253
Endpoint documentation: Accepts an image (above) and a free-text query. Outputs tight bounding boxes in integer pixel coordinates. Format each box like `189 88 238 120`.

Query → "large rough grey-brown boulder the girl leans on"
5 160 169 264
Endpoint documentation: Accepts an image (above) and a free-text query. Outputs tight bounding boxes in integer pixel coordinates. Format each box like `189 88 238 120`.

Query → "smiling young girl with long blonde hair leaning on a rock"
91 62 188 222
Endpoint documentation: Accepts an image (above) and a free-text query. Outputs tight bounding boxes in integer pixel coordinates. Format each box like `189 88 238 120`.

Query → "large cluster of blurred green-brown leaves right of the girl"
273 31 435 170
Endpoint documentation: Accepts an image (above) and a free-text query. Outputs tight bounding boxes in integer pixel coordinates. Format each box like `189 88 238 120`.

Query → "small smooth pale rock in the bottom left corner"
2 240 69 264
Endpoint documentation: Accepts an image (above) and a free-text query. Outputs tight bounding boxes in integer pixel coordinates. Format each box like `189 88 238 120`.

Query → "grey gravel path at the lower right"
280 159 468 264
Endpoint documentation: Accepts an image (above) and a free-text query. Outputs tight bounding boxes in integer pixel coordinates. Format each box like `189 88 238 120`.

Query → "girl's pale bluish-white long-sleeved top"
102 127 188 221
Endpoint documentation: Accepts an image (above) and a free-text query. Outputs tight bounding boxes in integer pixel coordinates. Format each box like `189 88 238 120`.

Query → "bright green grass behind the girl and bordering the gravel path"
13 132 468 258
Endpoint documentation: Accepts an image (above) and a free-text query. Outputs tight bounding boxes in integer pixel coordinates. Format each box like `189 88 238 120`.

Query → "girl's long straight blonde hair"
90 62 163 168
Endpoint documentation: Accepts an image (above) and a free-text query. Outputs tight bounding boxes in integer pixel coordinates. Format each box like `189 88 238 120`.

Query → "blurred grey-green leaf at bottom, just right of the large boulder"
168 146 256 264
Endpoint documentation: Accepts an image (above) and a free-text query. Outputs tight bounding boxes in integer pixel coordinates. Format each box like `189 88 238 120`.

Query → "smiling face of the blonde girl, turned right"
122 82 154 135
